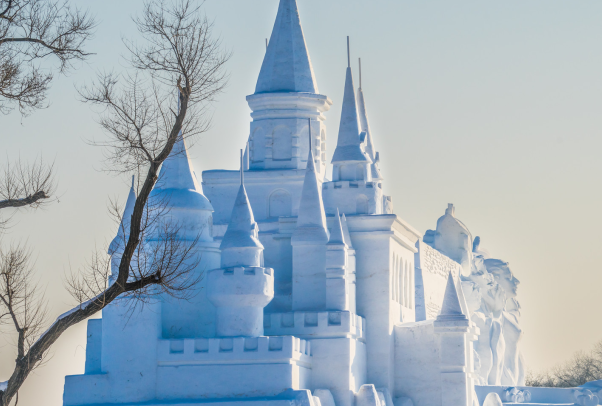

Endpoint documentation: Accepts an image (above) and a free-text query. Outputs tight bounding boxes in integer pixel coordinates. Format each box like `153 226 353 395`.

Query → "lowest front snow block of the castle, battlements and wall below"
157 336 312 400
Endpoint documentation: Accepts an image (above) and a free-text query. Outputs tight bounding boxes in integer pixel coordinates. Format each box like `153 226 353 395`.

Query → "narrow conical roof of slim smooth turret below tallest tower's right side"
293 148 328 243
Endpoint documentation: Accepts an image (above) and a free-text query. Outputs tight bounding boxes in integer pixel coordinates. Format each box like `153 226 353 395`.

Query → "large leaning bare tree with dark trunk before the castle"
0 0 230 406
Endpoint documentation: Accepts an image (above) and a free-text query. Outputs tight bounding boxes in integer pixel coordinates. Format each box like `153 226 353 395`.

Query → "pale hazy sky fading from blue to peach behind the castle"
0 0 602 406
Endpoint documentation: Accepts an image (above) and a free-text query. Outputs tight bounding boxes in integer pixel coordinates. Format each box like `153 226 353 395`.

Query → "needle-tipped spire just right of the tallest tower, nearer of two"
332 37 370 163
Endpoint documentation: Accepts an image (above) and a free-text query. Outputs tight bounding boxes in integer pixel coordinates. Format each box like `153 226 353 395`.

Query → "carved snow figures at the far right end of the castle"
423 204 525 386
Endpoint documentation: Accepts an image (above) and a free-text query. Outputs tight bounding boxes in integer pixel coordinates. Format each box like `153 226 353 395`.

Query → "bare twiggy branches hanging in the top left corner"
0 0 95 115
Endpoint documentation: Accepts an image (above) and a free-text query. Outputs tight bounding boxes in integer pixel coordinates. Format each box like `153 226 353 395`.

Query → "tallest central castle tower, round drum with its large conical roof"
247 0 332 174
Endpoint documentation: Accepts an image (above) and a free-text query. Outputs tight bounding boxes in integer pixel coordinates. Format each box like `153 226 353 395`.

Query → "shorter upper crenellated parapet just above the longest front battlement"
263 311 366 341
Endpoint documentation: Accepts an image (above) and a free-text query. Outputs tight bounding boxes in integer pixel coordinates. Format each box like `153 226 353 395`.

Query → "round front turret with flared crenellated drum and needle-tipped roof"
207 150 274 337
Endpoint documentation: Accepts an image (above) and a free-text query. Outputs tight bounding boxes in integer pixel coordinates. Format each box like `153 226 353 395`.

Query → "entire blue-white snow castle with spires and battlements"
64 0 556 406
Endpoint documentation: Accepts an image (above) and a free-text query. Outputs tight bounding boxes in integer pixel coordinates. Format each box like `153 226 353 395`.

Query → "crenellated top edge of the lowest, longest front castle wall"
157 336 311 367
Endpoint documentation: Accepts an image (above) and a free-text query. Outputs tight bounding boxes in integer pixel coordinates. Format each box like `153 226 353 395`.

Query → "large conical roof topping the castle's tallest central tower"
255 0 318 93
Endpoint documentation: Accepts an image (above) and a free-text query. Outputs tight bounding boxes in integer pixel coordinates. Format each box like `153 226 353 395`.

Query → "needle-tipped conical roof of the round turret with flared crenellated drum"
220 150 263 268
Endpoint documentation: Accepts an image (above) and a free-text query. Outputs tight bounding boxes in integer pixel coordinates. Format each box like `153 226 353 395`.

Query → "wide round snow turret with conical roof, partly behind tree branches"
146 133 220 338
